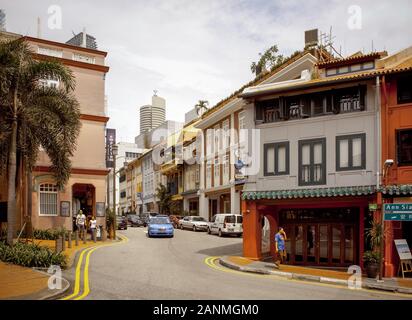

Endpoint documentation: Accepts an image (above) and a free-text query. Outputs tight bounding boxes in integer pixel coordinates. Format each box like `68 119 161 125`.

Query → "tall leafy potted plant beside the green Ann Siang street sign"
363 221 385 278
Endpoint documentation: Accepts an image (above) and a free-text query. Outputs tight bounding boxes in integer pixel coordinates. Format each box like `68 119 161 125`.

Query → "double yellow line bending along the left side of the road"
61 235 129 300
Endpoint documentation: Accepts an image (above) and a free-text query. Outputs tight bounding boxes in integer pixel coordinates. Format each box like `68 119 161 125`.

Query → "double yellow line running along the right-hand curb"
204 257 412 299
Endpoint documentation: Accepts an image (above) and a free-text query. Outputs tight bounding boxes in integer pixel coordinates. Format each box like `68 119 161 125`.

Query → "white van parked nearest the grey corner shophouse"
207 213 243 237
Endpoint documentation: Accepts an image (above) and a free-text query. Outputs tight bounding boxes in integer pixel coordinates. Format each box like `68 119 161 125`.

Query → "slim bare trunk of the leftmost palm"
7 119 17 245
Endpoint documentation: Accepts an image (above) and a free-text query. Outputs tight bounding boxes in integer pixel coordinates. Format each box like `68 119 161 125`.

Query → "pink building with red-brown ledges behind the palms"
0 37 109 230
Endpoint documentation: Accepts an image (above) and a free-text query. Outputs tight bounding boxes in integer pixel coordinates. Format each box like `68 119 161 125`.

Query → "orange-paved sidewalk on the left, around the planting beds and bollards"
0 239 110 300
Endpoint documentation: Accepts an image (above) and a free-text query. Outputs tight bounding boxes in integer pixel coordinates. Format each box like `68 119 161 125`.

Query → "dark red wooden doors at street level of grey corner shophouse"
279 208 359 267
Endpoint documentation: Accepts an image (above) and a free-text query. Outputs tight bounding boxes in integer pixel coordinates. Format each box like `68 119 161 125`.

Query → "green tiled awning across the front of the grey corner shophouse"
242 186 376 200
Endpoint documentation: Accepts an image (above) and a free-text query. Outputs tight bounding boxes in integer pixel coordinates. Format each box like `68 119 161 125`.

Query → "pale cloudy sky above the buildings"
0 0 412 142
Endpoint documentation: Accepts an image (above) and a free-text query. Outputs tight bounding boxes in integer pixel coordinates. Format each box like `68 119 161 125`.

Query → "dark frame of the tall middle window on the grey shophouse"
298 138 326 186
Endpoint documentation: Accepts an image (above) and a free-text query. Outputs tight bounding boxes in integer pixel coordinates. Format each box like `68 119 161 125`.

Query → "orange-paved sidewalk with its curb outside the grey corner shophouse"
219 256 412 295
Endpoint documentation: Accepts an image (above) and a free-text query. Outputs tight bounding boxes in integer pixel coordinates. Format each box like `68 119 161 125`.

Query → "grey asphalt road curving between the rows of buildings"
65 228 407 300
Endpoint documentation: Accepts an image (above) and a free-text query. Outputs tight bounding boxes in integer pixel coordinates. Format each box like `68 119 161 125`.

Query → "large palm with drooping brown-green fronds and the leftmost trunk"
0 38 81 244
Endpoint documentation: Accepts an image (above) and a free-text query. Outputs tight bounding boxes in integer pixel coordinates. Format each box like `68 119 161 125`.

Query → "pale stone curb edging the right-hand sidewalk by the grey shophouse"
219 257 412 295
